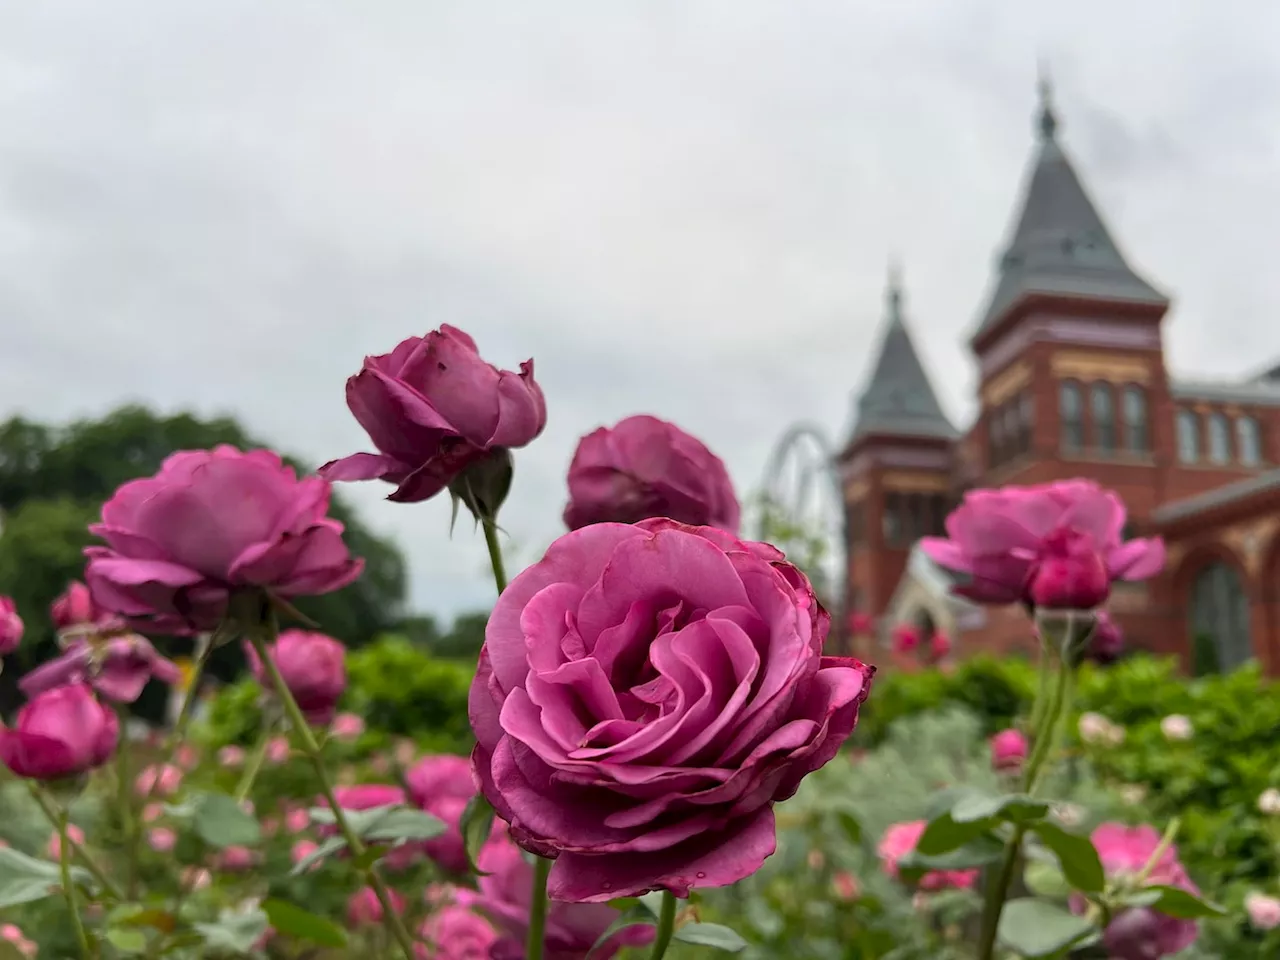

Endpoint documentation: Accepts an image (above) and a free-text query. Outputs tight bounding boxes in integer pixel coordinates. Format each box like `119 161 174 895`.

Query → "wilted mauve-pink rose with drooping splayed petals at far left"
18 634 182 703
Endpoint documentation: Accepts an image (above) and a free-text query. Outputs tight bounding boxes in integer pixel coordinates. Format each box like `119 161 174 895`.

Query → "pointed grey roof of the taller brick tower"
974 84 1169 339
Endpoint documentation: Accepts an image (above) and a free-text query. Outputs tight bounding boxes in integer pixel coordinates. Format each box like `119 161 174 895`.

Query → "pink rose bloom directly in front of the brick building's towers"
920 480 1165 609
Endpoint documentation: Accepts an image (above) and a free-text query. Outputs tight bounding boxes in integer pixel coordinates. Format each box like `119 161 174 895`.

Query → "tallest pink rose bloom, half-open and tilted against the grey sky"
320 324 547 503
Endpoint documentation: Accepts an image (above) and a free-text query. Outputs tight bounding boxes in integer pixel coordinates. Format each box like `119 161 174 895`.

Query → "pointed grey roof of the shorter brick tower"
851 276 959 442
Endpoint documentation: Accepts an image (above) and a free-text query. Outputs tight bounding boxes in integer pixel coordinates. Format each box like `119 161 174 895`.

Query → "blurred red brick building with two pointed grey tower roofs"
838 88 1280 673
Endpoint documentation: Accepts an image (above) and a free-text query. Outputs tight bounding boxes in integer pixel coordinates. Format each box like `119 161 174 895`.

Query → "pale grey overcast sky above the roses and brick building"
0 0 1280 614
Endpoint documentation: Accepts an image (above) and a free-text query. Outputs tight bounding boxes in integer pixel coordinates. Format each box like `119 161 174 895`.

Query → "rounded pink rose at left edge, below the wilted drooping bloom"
0 684 120 780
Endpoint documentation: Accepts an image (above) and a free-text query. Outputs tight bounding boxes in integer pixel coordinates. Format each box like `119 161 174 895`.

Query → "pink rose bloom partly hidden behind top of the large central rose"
564 416 741 534
